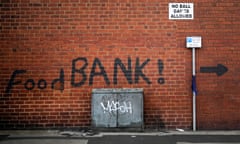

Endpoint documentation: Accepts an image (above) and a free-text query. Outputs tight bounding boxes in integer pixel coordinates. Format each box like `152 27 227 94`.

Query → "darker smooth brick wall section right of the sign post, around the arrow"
197 0 240 129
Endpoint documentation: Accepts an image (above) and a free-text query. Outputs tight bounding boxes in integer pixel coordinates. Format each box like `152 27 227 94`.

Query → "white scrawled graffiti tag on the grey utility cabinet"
101 101 132 114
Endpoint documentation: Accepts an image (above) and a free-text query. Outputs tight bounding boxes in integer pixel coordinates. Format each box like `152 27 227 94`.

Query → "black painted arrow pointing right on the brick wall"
200 64 228 76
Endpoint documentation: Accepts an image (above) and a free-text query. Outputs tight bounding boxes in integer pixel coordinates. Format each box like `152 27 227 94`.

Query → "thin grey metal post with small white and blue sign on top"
186 36 202 131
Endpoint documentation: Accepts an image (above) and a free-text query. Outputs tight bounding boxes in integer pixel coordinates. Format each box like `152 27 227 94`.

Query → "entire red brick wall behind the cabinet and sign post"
0 0 240 129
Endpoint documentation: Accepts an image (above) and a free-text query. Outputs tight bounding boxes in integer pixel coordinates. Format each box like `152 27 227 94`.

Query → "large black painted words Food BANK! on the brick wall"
6 57 165 93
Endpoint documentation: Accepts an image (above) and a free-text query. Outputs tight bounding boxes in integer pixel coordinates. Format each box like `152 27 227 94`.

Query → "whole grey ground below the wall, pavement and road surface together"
0 130 240 144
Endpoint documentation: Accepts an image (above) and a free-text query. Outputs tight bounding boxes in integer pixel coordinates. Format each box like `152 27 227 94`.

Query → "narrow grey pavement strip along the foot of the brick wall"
0 129 240 137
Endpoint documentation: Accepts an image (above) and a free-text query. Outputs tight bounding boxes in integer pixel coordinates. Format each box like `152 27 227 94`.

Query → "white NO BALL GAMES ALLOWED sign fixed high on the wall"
168 3 194 20
